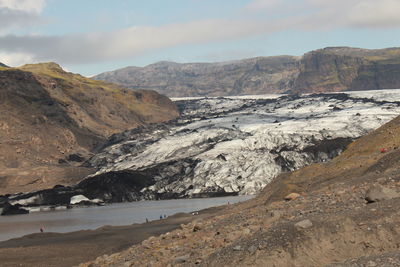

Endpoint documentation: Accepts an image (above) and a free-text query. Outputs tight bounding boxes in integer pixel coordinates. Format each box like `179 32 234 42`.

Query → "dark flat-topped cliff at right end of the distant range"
288 47 400 93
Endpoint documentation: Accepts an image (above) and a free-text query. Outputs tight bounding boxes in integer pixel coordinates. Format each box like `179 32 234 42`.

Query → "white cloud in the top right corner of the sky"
244 0 400 30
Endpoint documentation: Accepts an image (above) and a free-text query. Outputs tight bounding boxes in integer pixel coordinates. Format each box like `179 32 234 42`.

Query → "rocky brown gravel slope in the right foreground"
81 113 400 267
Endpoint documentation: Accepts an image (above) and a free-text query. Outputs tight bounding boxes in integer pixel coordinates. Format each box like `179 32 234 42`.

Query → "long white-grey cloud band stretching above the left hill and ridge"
0 20 284 64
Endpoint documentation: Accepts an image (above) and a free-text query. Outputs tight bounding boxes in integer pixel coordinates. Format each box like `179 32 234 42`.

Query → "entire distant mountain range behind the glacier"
94 47 400 97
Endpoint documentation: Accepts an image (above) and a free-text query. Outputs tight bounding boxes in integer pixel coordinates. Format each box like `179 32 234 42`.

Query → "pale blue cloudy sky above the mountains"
0 0 400 76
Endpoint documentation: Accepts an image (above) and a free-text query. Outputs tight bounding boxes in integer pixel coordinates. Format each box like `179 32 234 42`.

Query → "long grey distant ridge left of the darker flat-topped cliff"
95 56 298 96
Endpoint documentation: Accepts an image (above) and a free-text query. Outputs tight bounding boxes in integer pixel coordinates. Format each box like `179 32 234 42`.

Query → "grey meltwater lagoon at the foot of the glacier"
0 196 252 241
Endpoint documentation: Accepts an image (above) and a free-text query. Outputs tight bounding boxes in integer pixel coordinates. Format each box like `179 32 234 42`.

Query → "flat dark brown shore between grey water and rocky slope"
0 208 220 267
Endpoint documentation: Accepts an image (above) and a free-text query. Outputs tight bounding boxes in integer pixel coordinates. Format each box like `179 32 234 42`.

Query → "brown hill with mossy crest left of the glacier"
0 63 178 193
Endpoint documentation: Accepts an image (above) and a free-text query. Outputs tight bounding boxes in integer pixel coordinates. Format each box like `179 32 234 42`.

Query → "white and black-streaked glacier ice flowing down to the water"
1 90 400 215
